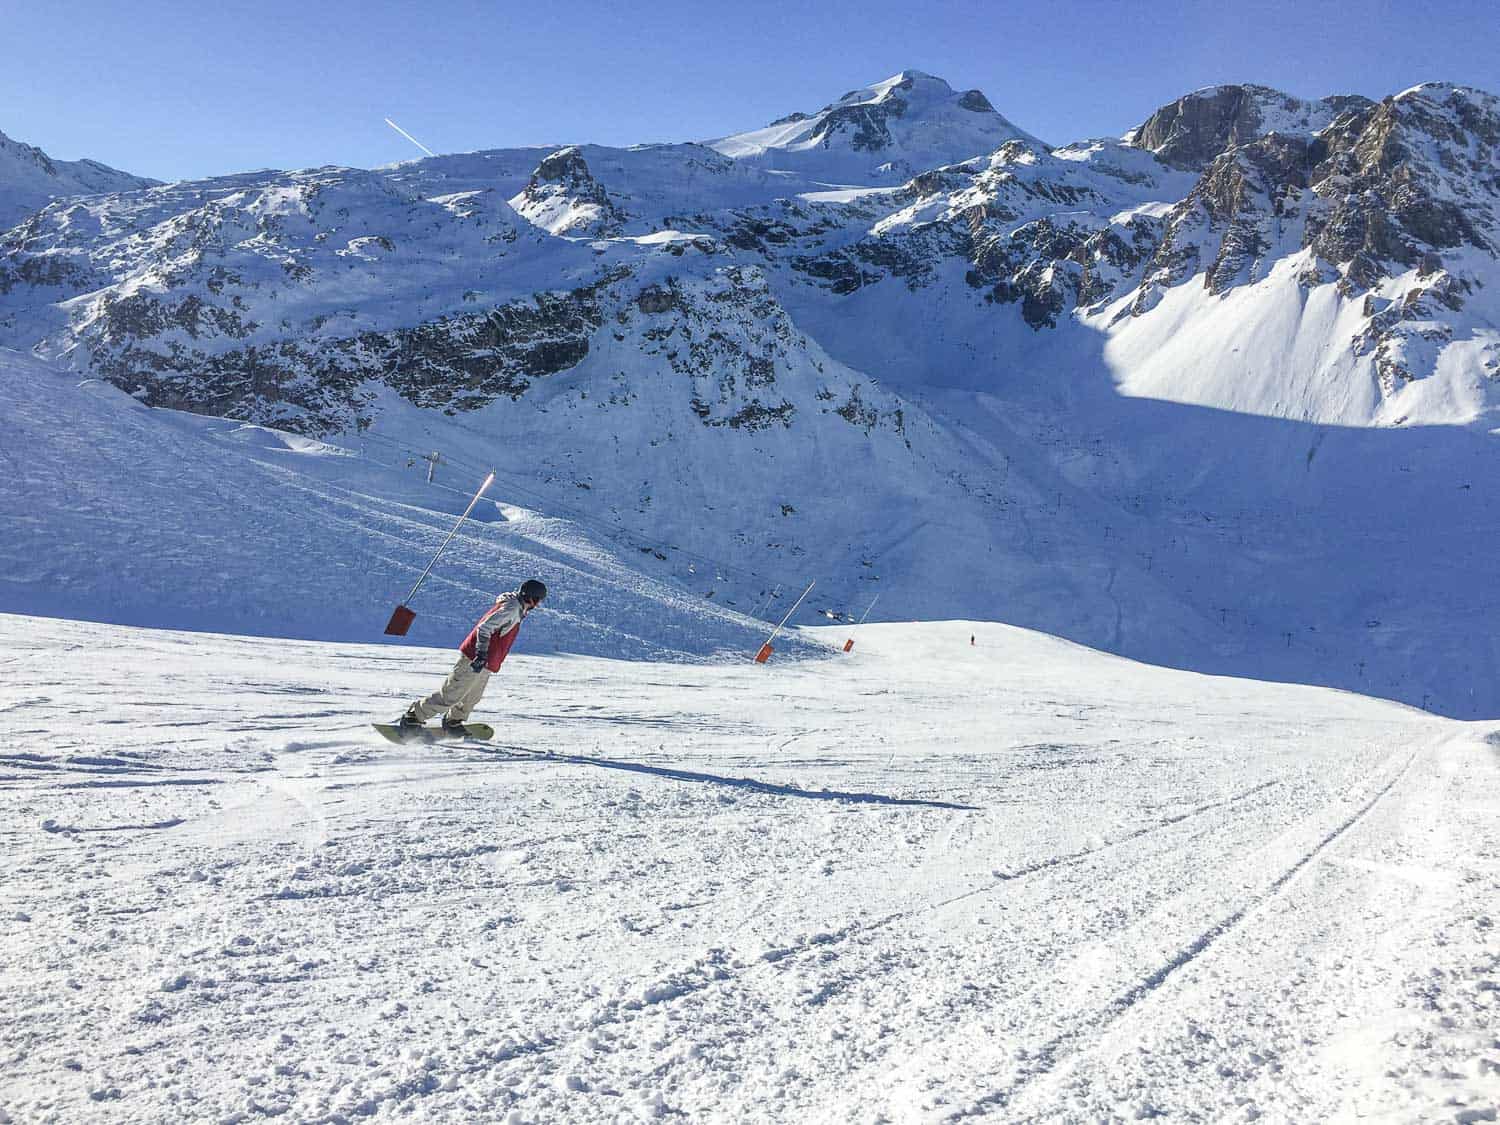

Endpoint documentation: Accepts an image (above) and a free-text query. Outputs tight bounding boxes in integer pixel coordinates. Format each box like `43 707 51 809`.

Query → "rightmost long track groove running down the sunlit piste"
947 752 1418 1121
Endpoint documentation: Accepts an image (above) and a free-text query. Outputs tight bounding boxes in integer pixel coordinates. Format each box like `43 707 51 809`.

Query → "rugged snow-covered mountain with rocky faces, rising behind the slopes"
0 72 1500 714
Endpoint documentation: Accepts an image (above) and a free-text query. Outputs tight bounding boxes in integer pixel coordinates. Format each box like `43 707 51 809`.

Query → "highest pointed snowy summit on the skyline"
707 71 1041 185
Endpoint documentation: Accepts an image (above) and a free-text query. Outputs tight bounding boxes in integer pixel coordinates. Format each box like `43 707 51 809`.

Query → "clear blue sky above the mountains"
0 0 1500 179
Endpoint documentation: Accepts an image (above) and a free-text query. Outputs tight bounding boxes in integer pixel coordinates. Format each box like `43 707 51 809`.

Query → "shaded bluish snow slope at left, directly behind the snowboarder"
0 343 795 659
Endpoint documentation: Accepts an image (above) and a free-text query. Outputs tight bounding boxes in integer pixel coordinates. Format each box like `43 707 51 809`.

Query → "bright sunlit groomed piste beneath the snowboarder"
0 615 1500 1122
